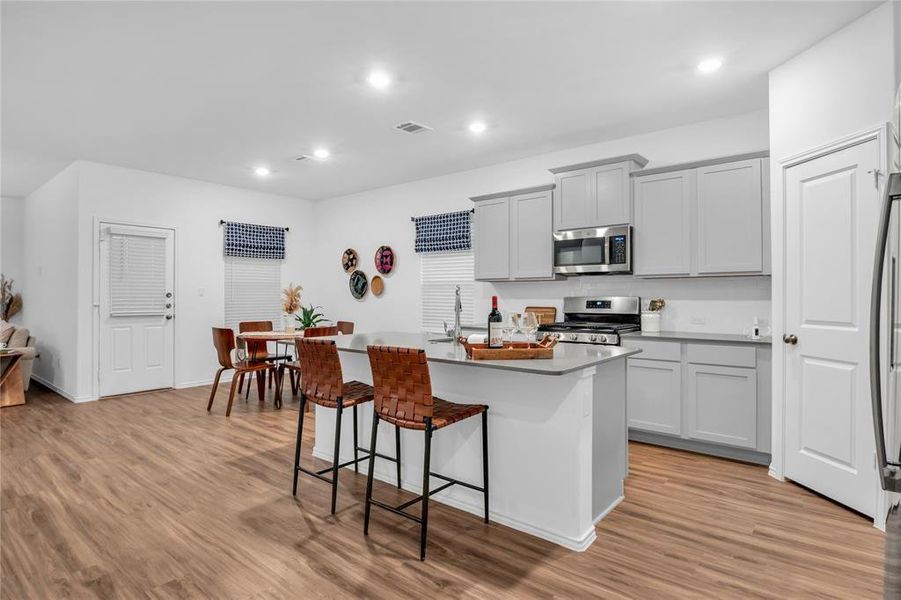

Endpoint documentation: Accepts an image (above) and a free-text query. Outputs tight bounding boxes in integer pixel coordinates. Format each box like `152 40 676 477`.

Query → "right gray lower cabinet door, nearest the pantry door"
685 364 757 448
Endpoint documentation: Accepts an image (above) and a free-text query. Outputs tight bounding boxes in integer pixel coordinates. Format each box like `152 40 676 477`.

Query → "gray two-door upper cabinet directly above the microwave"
551 154 648 231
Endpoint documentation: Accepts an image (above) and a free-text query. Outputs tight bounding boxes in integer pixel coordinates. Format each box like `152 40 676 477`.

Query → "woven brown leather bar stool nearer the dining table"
291 338 400 514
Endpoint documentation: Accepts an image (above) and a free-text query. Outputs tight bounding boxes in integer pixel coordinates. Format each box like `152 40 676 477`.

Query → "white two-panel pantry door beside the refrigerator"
785 140 880 516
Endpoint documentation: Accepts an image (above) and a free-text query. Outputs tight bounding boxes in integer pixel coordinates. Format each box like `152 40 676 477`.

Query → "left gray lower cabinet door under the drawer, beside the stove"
626 358 682 435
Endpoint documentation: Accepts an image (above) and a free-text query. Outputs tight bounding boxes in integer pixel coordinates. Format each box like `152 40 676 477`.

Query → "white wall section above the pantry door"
769 2 901 162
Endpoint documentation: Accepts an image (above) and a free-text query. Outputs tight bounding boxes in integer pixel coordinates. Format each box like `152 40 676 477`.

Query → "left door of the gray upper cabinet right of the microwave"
632 169 696 275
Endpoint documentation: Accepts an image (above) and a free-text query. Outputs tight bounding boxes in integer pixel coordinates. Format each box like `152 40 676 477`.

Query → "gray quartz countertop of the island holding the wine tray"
331 331 641 375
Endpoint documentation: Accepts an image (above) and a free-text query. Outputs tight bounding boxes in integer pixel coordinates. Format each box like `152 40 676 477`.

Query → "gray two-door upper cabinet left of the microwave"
471 184 554 281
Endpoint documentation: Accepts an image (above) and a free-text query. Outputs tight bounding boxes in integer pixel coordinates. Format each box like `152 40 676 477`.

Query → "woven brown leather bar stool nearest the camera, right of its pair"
363 346 488 560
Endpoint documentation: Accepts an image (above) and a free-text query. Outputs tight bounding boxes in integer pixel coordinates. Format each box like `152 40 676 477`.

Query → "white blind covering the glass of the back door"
109 233 166 317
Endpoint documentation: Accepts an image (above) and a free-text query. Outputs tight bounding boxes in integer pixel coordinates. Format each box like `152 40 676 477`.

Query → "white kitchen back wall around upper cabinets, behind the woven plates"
308 111 770 332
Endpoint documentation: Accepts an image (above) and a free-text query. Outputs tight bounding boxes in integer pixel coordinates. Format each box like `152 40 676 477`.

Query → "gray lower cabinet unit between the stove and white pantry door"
623 337 771 463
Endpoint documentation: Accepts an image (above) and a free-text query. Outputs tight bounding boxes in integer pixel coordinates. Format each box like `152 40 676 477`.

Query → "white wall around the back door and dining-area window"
77 162 316 396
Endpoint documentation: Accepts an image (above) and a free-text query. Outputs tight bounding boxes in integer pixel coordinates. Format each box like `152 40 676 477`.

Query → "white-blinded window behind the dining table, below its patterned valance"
225 256 282 331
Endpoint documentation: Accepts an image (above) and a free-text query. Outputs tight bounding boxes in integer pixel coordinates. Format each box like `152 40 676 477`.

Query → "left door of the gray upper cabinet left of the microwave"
473 198 510 280
